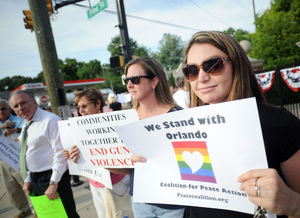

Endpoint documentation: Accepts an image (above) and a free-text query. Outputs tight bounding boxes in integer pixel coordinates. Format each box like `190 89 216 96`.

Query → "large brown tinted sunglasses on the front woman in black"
182 57 230 80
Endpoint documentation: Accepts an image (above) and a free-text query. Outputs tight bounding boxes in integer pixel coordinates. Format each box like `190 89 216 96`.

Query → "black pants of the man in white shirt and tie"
30 170 79 218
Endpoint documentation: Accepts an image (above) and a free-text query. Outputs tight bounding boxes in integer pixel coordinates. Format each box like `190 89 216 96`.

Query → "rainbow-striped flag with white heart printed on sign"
172 141 217 183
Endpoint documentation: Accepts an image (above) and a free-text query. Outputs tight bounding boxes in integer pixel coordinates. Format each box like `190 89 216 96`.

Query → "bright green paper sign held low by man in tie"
29 195 68 218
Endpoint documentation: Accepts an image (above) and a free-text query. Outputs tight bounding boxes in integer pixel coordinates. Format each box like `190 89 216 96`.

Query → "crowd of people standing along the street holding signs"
0 31 300 218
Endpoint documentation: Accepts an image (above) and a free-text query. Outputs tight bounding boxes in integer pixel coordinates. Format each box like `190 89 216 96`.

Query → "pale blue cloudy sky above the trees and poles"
0 0 271 79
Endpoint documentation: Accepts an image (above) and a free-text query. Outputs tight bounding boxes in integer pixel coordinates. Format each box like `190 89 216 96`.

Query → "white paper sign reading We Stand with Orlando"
116 98 268 214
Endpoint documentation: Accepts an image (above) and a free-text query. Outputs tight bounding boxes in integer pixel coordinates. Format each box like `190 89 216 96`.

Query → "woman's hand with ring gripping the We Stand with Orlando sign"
238 169 300 216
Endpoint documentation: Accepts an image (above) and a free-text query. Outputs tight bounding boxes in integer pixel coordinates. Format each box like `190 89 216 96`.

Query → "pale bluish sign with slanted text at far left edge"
0 134 20 170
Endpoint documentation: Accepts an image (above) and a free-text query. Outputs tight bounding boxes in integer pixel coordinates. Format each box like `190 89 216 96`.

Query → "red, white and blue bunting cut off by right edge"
280 66 300 92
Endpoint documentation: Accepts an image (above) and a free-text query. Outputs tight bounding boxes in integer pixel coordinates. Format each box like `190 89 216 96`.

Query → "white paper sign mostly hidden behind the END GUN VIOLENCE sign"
58 120 112 189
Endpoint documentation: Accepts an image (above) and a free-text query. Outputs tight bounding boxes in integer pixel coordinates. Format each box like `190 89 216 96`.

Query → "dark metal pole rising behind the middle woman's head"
116 0 132 65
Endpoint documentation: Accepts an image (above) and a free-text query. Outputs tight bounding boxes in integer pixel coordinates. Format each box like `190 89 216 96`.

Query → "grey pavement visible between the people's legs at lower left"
0 175 97 218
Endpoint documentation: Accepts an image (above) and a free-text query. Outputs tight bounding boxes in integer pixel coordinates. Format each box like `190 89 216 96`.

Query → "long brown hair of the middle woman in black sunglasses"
125 57 175 108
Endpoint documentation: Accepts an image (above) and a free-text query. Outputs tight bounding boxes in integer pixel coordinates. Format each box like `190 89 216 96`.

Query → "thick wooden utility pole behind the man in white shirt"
28 0 67 114
